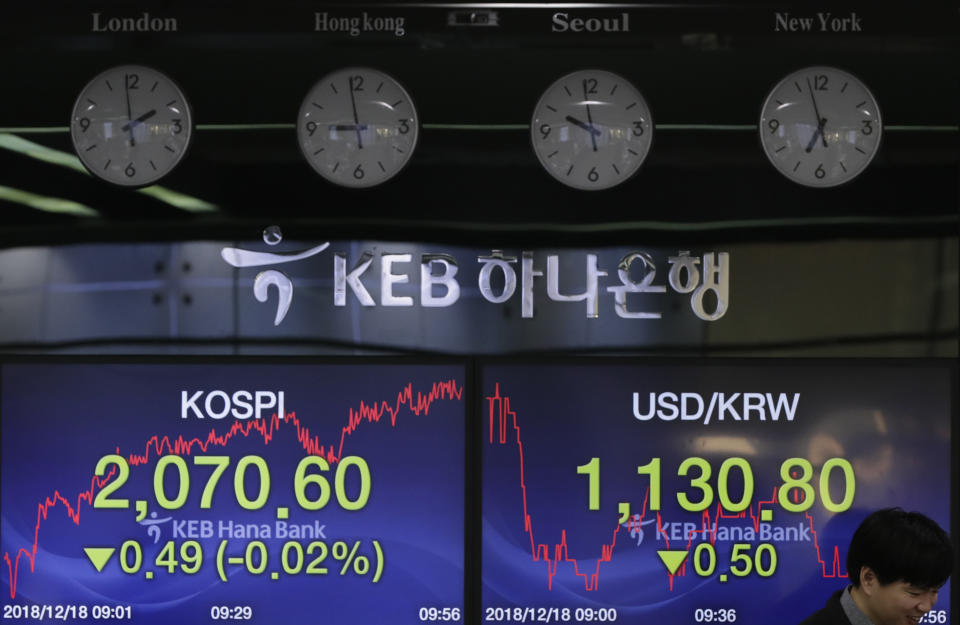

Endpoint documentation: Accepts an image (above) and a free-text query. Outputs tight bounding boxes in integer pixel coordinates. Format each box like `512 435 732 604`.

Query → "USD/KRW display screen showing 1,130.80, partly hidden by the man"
480 360 956 625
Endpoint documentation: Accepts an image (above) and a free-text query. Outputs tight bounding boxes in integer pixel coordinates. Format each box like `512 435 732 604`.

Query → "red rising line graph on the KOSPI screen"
3 380 463 599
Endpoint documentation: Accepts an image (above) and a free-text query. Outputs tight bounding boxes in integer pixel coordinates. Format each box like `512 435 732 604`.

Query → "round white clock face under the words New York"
760 67 883 187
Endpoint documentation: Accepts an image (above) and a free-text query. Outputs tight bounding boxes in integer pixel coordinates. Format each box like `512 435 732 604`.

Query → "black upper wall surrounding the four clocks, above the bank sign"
0 2 960 246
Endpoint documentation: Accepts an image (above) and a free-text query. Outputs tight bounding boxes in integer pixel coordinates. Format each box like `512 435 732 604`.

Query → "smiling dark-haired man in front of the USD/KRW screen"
800 508 953 625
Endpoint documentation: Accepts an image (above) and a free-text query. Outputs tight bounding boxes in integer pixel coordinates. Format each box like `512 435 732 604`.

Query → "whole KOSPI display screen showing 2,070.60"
0 360 465 625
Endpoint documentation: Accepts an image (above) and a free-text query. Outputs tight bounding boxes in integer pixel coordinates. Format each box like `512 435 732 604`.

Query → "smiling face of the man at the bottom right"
851 567 940 625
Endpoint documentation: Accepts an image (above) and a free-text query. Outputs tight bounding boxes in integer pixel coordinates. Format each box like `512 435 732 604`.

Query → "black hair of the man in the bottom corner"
847 508 953 588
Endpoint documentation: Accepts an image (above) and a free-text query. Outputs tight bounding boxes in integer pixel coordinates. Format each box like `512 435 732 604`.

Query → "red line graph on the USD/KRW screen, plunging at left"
486 383 846 592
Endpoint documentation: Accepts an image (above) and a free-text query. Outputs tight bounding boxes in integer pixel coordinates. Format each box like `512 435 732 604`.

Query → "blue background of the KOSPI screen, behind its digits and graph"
0 363 465 625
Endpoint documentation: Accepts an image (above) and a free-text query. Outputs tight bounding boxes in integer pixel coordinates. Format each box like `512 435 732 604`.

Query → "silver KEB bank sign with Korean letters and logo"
221 229 731 326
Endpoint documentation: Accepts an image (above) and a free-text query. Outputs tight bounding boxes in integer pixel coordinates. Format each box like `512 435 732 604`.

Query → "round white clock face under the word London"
70 65 193 187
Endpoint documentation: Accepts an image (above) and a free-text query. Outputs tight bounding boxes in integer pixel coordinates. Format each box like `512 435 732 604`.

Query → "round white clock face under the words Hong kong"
297 67 419 187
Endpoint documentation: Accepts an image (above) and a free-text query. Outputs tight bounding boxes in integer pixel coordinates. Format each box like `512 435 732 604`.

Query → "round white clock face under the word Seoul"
530 70 653 190
